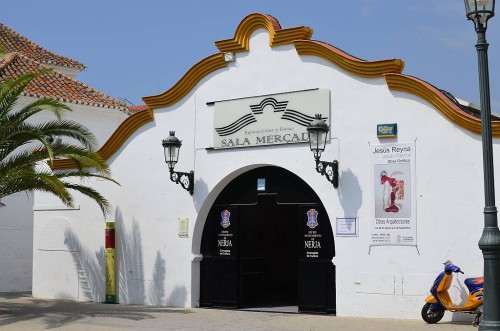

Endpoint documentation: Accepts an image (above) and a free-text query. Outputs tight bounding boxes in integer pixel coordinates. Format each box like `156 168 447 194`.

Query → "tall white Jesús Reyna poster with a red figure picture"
370 143 417 246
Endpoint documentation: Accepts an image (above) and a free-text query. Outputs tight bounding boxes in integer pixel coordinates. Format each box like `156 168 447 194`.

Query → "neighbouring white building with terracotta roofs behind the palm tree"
0 23 129 292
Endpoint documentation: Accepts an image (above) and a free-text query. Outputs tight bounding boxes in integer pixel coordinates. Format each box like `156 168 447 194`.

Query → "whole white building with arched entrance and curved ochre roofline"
33 14 500 318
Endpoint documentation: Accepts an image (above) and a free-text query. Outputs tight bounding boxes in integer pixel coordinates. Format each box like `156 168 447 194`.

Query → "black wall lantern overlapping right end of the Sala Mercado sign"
306 114 339 188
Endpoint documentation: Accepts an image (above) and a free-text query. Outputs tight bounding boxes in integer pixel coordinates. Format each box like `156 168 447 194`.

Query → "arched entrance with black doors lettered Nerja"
200 166 335 313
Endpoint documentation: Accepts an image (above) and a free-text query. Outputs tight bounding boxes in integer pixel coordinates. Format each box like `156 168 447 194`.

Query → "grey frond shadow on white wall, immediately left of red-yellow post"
64 229 105 302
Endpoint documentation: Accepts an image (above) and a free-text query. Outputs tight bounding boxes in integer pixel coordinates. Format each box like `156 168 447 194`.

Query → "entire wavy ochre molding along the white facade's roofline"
52 14 500 170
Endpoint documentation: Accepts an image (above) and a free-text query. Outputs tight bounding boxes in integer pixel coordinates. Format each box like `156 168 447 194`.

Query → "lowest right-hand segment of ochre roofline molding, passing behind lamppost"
385 74 500 138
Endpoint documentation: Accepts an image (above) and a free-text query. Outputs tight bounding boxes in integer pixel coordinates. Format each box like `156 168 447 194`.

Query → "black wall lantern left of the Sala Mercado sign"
161 131 194 195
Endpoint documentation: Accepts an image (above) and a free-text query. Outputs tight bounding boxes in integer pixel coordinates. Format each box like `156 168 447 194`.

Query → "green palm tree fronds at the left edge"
0 71 116 215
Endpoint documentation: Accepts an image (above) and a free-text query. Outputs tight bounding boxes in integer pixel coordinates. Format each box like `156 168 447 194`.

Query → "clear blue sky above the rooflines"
0 0 500 113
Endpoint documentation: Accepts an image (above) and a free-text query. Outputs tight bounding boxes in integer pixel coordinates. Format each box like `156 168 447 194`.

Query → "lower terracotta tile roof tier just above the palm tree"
0 53 129 113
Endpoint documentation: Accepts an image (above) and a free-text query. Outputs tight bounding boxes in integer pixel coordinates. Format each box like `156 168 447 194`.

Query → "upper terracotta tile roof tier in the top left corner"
0 23 86 70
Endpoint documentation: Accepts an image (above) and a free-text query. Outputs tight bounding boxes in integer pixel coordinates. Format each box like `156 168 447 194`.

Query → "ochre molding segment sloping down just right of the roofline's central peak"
293 40 405 78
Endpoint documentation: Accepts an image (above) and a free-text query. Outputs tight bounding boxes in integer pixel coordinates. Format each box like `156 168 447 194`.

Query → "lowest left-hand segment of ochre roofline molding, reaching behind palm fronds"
51 109 154 170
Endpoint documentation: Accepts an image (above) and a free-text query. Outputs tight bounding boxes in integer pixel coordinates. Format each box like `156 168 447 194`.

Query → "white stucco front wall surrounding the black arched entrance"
33 30 500 319
